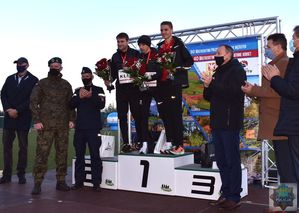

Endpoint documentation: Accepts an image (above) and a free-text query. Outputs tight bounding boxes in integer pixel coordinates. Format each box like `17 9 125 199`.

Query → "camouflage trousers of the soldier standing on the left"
32 129 69 183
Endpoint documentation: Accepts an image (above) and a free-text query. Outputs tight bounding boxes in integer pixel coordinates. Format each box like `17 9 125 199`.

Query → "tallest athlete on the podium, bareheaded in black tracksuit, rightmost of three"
158 21 193 154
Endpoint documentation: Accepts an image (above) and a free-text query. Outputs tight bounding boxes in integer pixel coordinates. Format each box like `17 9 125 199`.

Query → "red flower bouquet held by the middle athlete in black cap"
123 58 148 91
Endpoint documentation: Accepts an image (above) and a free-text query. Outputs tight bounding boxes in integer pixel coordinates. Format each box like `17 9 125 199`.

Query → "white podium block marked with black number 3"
175 164 248 200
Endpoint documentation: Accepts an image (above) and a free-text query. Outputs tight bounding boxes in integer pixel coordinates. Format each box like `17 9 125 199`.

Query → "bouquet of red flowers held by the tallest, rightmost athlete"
157 49 176 80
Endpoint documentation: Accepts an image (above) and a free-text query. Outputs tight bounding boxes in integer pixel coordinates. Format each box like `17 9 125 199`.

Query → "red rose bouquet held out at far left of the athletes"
94 58 114 92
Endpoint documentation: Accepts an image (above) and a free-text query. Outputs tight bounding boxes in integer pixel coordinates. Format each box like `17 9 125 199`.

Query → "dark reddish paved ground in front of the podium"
0 168 284 213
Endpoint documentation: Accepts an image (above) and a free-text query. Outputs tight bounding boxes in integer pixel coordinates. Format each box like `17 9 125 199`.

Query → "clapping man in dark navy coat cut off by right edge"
262 26 299 205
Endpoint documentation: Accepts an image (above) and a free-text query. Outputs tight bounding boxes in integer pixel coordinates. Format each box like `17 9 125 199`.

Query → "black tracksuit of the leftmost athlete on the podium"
111 47 141 144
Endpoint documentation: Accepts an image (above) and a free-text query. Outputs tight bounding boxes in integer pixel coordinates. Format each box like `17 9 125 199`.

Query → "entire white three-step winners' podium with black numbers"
72 153 248 200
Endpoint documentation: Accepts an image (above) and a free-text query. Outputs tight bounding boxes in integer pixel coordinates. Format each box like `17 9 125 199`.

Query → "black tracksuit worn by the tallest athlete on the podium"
158 36 194 146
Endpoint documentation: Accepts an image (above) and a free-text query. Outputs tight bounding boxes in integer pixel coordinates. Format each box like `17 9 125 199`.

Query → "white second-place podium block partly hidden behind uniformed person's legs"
72 156 118 190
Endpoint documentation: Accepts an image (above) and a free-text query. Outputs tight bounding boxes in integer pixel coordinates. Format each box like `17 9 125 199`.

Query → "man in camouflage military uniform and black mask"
30 57 75 195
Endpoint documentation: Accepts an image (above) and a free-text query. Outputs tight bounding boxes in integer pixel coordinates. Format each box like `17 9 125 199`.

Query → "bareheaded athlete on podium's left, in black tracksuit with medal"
105 33 141 152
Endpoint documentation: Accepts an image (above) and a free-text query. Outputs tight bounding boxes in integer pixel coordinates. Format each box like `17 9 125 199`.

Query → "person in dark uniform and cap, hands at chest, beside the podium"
70 67 105 191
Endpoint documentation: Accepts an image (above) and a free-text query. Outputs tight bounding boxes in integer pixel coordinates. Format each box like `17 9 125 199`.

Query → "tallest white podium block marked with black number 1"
118 153 194 195
